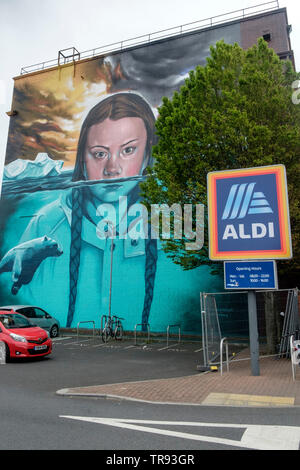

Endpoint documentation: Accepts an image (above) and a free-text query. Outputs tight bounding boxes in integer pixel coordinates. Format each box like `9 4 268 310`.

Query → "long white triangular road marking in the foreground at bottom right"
60 415 300 450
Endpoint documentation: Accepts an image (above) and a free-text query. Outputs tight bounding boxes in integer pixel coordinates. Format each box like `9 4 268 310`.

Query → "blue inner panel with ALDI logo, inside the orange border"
216 174 280 252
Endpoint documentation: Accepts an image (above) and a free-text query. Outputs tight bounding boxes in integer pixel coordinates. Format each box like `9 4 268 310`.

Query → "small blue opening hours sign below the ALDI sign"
224 261 278 290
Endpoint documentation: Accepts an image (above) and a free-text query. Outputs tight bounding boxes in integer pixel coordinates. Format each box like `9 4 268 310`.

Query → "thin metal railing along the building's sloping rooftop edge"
20 0 279 75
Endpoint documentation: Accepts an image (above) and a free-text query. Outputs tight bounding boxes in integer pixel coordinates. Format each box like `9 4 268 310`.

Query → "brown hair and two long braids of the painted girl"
67 92 157 330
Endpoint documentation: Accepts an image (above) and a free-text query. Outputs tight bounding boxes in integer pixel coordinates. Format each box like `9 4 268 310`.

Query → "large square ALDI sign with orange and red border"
207 165 292 260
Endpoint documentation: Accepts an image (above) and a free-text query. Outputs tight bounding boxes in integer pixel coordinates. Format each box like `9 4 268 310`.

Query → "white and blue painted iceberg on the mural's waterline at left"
3 153 64 180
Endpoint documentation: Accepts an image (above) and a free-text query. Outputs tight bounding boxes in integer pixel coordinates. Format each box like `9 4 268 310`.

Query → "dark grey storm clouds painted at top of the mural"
109 24 240 106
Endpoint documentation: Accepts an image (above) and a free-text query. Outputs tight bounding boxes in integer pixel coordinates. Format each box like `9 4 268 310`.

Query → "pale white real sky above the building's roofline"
0 0 300 181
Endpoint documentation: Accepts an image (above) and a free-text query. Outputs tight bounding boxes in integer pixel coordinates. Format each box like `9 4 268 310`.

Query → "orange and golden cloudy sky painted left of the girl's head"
6 59 113 168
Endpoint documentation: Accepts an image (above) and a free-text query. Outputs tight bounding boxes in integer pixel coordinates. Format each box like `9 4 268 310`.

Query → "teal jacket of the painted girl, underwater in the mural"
3 191 219 332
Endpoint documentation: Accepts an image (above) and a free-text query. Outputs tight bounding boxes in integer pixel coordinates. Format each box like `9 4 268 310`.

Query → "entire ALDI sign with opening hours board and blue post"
207 165 292 375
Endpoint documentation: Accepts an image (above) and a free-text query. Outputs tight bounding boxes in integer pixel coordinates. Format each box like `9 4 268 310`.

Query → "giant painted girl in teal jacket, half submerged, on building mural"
0 91 220 331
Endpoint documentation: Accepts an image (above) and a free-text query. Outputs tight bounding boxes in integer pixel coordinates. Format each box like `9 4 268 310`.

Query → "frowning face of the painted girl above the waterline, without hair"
84 117 147 180
